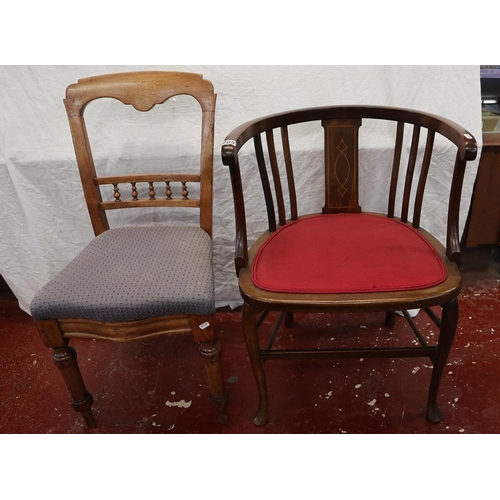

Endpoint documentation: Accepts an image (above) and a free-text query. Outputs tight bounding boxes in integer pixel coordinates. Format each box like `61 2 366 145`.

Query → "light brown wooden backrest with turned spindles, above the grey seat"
64 71 216 236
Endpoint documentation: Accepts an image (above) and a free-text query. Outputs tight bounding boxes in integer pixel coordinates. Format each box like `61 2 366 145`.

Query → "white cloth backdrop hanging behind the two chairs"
0 65 481 311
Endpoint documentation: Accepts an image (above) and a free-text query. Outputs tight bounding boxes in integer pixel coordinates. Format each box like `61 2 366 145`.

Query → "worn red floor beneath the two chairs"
0 254 500 434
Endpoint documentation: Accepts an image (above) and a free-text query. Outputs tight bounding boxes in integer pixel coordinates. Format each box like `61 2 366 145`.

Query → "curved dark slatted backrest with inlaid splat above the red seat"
222 106 477 273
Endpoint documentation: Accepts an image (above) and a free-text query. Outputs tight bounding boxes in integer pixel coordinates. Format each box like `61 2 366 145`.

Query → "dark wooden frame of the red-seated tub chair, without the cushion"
221 106 477 425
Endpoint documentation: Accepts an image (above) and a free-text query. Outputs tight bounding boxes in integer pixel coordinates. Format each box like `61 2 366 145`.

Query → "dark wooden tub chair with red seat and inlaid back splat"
221 106 476 425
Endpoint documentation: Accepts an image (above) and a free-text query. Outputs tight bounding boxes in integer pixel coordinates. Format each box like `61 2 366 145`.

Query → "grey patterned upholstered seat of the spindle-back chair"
30 226 215 322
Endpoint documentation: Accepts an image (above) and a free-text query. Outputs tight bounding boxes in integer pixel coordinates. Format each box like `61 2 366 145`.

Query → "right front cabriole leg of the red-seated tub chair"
427 299 458 423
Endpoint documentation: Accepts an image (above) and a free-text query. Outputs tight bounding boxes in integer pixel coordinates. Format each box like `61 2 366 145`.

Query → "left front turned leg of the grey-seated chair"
53 345 96 428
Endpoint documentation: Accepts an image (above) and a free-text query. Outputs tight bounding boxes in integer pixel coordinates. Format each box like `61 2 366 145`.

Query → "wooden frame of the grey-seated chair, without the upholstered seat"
36 71 228 427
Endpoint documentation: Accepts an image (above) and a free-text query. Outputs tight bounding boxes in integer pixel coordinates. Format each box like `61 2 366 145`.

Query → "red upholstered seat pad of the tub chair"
252 214 447 293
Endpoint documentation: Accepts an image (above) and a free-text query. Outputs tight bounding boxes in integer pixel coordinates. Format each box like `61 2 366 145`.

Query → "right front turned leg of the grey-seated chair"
200 340 228 424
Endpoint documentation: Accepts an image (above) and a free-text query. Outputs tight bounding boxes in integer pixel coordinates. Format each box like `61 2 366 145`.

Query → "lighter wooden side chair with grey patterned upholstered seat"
31 71 227 427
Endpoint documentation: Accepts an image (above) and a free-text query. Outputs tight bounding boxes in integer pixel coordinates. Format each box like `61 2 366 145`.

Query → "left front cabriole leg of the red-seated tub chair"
243 304 269 426
